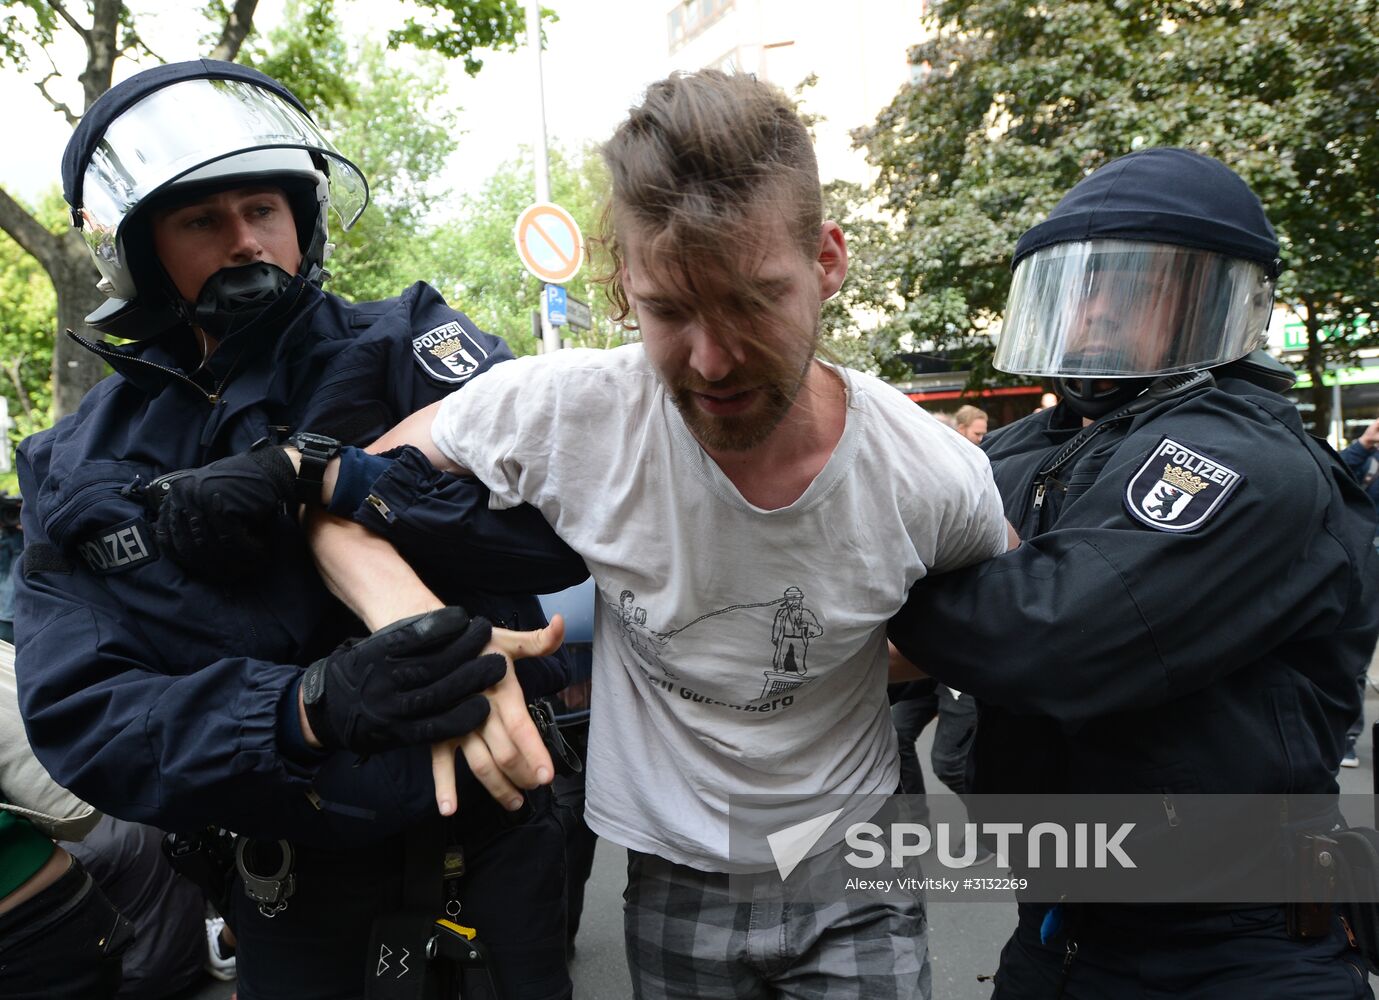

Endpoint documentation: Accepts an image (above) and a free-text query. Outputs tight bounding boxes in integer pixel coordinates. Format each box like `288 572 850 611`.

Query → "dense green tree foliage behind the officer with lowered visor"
856 0 1379 419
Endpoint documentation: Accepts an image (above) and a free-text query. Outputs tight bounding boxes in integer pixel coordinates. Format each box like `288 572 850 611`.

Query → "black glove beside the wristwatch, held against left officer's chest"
146 446 296 581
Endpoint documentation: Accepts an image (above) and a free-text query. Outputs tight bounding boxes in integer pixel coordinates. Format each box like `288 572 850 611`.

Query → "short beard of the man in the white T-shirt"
666 330 818 451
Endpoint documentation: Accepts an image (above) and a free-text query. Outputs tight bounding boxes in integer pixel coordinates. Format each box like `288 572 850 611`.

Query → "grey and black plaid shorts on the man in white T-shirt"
623 851 929 1000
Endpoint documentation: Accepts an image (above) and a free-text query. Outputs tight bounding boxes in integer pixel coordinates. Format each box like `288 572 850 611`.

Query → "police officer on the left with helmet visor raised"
15 61 586 1000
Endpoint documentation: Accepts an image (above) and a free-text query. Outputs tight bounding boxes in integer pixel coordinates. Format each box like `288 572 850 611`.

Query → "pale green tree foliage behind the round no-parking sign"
422 148 634 354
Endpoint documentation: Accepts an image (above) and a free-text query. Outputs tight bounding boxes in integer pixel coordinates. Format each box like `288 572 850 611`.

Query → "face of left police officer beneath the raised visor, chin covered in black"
153 188 302 302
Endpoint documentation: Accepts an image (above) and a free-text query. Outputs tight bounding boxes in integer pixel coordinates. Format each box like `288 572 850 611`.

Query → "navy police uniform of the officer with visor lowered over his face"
891 368 1379 999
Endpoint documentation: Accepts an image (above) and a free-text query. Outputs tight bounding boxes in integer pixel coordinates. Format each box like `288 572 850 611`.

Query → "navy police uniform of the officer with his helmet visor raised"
17 274 585 1000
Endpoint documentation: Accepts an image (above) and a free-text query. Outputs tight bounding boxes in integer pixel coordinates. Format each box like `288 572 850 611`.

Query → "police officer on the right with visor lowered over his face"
889 149 1379 1000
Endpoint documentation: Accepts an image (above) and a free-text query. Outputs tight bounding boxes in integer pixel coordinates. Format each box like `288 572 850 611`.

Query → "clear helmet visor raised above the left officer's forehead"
80 80 368 258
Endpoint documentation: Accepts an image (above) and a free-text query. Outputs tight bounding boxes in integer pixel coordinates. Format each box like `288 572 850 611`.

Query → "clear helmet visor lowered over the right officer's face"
994 240 1273 378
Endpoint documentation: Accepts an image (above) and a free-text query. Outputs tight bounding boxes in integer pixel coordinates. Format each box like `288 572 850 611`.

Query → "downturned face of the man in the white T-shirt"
623 215 847 451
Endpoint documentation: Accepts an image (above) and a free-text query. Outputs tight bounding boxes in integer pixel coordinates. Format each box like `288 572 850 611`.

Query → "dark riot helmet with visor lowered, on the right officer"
994 149 1280 418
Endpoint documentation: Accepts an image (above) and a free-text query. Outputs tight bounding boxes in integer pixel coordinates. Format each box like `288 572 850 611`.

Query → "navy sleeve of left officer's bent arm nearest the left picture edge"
15 434 434 847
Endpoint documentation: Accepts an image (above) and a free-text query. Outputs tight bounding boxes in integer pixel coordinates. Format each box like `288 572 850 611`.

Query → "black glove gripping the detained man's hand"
302 607 507 753
